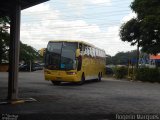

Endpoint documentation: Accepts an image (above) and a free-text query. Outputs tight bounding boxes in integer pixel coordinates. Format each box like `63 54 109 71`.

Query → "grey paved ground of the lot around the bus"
0 71 160 120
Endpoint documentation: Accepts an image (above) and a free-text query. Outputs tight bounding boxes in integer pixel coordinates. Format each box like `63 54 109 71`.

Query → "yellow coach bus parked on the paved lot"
44 40 106 85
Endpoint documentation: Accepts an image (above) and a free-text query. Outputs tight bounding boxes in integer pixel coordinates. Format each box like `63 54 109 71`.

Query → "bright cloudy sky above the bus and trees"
20 0 136 56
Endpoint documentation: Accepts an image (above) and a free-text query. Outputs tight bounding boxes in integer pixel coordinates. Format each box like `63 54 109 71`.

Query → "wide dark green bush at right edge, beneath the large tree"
136 68 160 82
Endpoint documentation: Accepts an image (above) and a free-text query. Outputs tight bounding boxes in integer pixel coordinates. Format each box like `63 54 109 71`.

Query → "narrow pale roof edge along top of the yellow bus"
49 40 105 51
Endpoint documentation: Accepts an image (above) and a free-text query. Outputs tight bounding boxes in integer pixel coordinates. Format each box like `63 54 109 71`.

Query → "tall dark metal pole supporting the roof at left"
8 0 21 100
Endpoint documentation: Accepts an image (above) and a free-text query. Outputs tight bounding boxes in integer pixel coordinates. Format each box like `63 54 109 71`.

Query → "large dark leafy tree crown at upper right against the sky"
120 0 160 54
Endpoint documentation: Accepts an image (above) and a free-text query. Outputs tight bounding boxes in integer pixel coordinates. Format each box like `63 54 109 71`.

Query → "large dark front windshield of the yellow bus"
46 42 78 70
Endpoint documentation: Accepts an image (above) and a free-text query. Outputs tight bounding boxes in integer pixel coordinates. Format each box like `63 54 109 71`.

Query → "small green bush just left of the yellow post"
115 67 127 79
